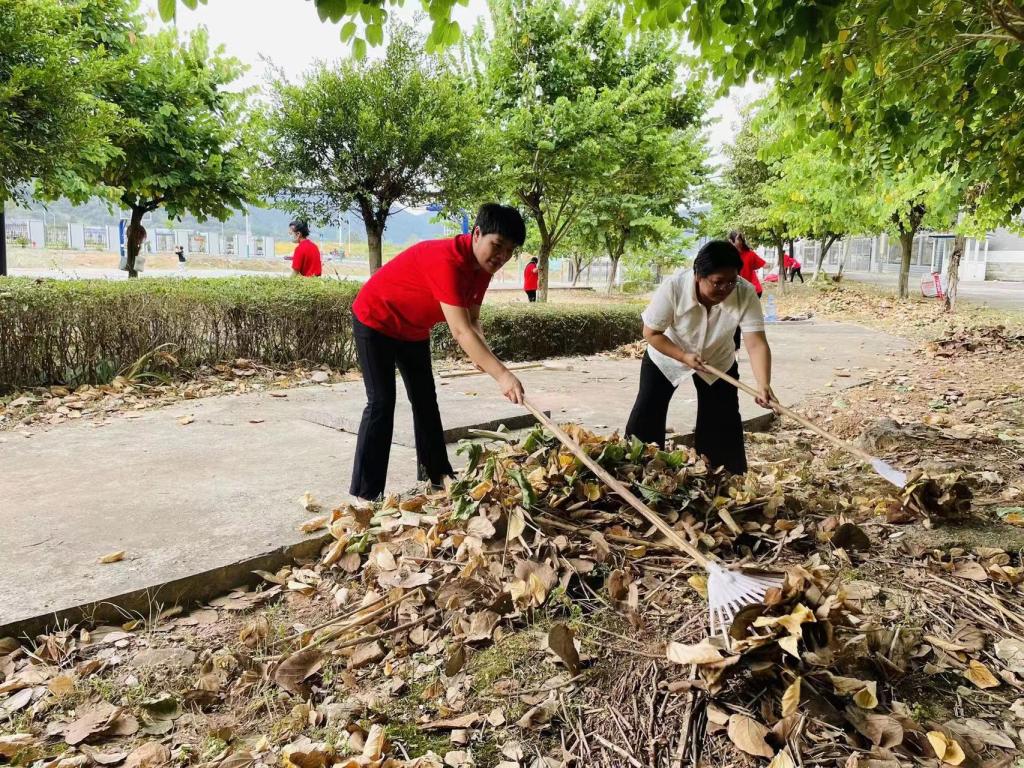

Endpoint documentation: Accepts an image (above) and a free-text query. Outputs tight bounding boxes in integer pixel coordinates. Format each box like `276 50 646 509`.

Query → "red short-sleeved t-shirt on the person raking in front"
352 234 490 341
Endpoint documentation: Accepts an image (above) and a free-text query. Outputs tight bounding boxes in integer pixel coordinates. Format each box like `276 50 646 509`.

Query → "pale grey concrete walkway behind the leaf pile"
0 323 905 634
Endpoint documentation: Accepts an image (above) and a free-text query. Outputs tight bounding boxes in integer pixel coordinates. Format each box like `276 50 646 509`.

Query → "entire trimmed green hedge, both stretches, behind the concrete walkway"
0 276 641 391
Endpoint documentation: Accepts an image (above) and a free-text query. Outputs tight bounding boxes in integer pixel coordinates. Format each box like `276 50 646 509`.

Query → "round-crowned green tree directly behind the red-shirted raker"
268 25 481 271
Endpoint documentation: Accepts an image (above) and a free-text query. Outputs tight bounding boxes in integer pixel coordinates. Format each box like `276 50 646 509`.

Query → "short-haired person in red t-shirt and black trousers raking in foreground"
349 203 526 500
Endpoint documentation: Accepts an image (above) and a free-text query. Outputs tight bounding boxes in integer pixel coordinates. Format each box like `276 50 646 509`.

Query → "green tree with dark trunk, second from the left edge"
98 30 257 278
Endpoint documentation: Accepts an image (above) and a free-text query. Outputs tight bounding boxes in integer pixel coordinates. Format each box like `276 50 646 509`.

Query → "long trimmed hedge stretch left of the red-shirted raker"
0 278 358 389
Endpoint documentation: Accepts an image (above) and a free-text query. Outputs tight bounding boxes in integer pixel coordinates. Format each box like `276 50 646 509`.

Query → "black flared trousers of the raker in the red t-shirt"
348 314 455 499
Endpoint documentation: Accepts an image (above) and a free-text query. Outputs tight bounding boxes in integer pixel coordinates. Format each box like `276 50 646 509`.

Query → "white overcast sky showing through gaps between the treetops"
141 0 762 162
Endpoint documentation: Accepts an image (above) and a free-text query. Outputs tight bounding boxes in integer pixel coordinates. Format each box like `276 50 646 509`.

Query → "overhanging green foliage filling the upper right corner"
671 0 1024 233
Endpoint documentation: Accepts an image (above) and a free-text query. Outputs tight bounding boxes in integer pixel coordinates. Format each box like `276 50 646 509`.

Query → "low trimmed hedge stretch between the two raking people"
431 304 643 360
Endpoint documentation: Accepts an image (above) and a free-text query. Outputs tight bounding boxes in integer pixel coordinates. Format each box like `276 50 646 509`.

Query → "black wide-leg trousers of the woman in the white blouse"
626 353 746 474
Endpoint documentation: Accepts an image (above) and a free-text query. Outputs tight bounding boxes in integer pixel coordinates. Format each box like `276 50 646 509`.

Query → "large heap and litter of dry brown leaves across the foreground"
0 427 1024 768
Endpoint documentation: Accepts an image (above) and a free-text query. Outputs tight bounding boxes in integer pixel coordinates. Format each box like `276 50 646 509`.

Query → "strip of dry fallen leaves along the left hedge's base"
0 355 351 435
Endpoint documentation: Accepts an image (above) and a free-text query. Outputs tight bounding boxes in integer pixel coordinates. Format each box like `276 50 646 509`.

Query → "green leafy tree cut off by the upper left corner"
0 0 134 274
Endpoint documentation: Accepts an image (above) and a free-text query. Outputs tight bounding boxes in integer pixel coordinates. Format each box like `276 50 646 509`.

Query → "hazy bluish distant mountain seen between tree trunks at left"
6 200 444 246
